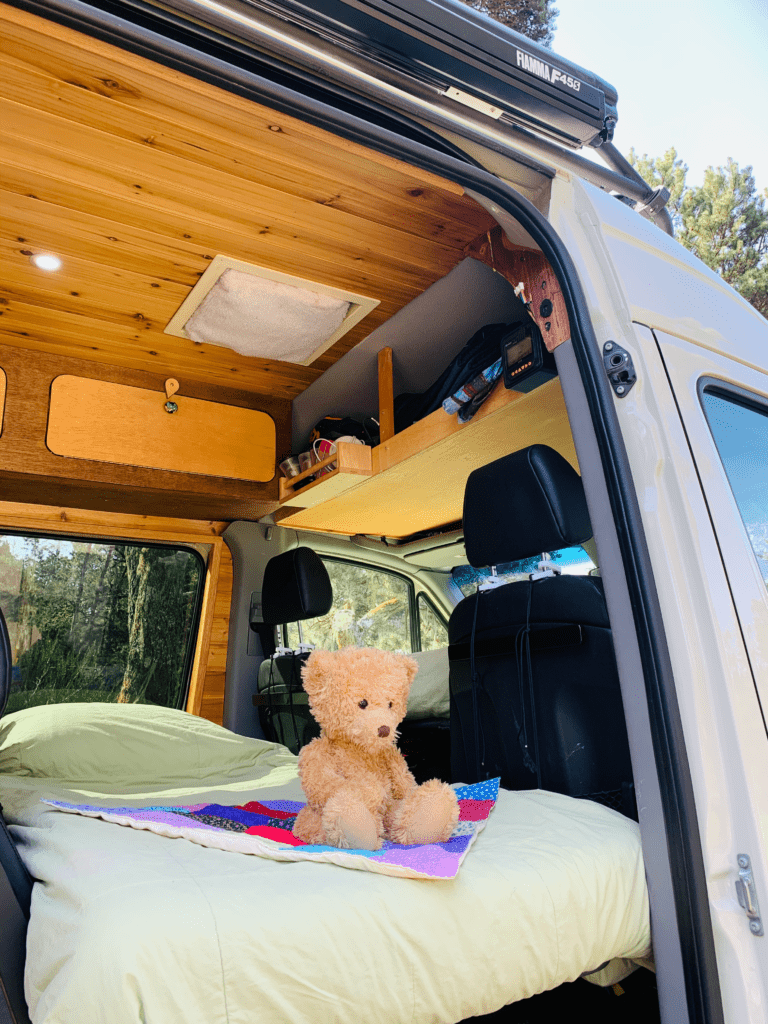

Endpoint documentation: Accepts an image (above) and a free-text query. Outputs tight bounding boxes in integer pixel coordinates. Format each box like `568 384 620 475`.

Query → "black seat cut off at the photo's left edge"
0 610 33 1024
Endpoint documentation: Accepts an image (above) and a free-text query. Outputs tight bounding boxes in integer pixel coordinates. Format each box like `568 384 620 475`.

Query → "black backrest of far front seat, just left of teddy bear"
253 651 321 754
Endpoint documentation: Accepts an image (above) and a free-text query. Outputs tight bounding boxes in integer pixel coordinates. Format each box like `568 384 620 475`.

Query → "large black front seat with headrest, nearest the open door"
449 444 635 816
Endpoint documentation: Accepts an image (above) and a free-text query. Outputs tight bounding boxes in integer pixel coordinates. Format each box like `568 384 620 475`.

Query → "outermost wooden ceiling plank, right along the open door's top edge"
0 4 462 196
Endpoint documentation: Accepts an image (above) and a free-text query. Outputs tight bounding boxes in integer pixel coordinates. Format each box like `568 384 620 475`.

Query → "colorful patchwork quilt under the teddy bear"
43 778 499 879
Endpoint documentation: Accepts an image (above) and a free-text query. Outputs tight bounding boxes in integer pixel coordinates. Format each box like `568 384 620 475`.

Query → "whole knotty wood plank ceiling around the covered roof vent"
0 5 493 399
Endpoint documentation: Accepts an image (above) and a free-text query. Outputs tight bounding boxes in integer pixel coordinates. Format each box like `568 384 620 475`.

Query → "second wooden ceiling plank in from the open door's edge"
0 65 490 246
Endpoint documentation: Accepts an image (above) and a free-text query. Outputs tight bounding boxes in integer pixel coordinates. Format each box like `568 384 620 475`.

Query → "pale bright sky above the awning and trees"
552 0 768 190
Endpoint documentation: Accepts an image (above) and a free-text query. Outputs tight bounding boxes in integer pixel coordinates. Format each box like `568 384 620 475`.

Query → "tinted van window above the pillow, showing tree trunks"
0 534 205 713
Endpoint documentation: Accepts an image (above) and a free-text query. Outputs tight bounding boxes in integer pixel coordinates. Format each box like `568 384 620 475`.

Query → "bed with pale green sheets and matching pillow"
0 705 650 1024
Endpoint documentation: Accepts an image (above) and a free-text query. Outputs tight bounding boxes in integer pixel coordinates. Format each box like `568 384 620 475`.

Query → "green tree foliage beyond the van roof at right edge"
628 148 768 317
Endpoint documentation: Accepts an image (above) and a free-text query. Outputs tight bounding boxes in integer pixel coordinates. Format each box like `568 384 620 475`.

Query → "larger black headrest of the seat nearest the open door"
463 444 592 568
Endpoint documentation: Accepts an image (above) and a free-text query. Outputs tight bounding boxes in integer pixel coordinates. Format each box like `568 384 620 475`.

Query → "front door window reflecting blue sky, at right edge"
701 387 768 587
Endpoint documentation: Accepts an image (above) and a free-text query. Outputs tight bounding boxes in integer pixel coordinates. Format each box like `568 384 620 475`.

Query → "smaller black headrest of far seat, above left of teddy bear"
261 548 334 626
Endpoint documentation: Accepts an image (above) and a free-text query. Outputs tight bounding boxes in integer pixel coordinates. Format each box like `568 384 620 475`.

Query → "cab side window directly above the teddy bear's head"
286 558 414 653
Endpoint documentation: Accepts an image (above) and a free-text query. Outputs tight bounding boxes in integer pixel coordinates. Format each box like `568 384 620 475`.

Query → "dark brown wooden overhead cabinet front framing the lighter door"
0 346 291 519
